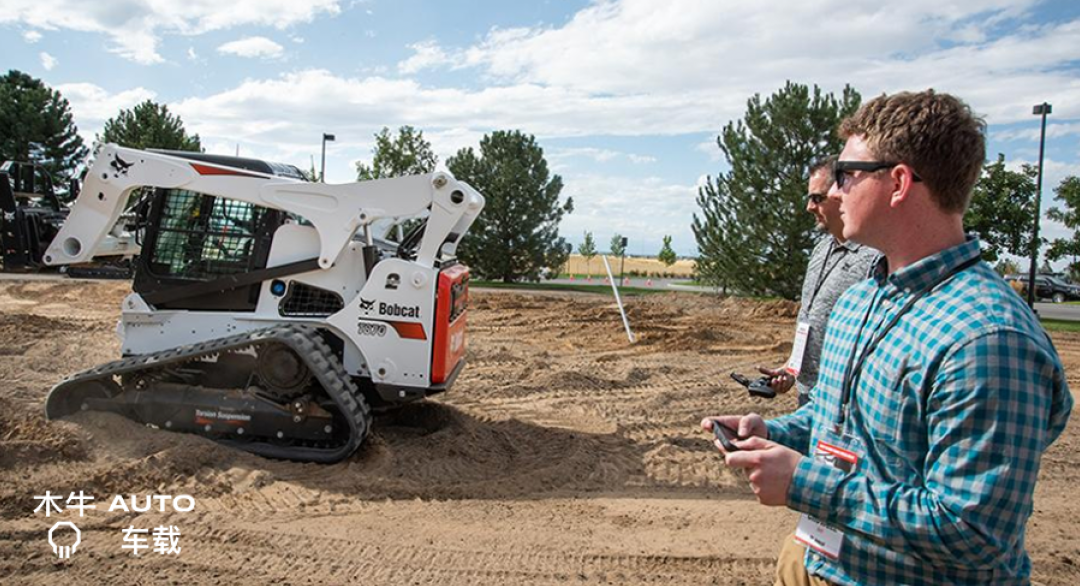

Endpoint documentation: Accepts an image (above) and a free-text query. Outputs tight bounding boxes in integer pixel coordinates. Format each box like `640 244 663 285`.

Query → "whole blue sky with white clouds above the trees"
0 0 1080 261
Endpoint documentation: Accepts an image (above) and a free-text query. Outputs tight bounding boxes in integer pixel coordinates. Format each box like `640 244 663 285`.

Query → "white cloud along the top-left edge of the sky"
0 0 341 65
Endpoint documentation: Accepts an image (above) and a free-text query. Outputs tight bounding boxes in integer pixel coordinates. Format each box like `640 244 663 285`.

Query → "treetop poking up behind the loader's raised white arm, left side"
97 99 202 152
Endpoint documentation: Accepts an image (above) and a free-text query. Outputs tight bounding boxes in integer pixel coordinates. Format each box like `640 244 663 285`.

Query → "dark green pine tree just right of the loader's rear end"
446 131 573 283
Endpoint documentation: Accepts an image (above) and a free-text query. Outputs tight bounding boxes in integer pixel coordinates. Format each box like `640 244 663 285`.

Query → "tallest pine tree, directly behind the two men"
692 82 861 299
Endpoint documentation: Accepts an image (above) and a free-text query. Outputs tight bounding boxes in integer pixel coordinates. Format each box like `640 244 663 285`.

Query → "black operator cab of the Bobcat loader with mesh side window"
133 151 303 312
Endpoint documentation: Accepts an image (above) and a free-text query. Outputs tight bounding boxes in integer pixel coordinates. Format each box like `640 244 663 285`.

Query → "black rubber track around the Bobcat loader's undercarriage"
45 324 372 463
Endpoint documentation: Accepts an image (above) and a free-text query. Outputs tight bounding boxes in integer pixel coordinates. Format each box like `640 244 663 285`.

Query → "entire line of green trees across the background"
8 70 1080 299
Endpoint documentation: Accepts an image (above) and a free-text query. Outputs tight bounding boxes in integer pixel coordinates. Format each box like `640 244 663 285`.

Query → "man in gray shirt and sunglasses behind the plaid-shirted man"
758 156 880 407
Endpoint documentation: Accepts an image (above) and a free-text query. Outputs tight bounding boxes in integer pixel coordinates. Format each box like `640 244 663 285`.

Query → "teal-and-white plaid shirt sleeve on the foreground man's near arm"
769 330 1072 568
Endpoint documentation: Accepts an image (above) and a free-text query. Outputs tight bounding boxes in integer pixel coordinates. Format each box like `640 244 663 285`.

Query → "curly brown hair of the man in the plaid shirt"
839 90 986 214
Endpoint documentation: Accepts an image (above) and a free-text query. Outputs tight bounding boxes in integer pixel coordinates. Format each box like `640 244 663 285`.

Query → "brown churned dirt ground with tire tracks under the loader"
0 281 1080 586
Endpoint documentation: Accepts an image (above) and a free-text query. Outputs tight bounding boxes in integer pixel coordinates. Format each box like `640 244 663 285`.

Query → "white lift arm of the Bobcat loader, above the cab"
44 145 484 275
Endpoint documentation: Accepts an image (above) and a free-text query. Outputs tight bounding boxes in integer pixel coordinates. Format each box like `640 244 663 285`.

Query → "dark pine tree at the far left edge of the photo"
0 69 86 186
